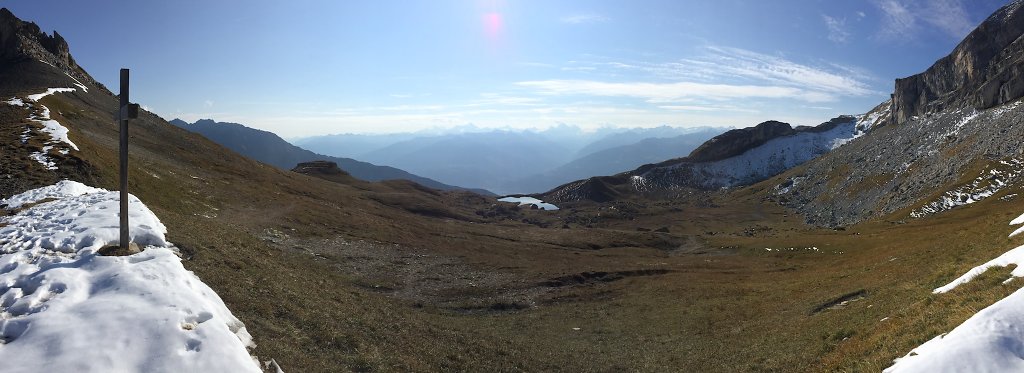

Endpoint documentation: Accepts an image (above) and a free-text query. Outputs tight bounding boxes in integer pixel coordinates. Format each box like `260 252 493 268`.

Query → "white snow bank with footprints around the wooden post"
0 181 260 372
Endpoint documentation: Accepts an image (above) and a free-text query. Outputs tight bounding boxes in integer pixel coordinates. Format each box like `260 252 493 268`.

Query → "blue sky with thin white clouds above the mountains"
0 0 1007 138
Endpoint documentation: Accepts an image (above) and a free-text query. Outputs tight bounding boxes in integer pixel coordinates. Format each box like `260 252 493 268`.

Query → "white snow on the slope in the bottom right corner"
886 211 1024 372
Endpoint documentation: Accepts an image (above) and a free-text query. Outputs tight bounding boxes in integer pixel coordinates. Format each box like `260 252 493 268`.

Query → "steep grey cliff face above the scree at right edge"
891 0 1024 124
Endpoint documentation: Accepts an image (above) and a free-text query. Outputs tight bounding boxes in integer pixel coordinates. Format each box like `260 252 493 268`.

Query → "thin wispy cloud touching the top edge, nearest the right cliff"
874 0 974 41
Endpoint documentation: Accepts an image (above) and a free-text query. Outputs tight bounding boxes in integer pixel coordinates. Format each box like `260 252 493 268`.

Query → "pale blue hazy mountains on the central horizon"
295 125 726 194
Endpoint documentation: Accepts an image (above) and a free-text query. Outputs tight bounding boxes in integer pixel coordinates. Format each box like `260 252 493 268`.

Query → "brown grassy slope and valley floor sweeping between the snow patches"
8 83 1024 372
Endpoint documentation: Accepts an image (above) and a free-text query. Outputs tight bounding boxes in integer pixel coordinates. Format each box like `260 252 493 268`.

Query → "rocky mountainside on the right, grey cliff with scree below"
778 1 1024 224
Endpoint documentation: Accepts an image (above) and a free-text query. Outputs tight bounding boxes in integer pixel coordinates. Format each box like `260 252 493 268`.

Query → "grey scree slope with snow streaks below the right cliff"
773 100 1024 226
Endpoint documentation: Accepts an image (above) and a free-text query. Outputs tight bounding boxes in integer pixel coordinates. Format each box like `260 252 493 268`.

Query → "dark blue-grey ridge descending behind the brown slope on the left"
169 119 494 195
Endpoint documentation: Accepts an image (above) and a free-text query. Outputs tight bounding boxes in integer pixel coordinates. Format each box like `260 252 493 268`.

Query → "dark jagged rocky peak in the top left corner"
0 8 100 86
